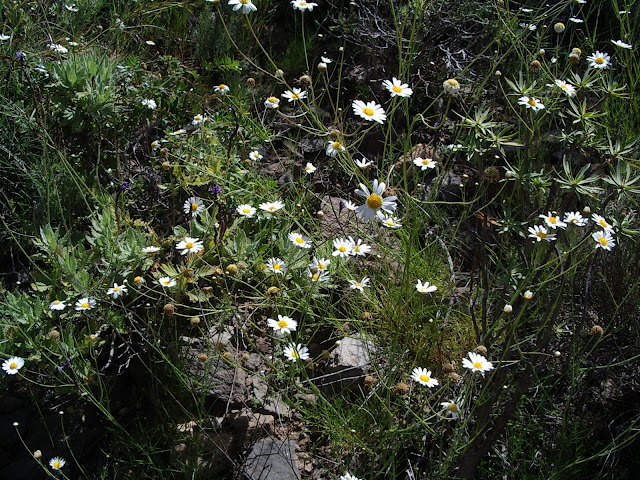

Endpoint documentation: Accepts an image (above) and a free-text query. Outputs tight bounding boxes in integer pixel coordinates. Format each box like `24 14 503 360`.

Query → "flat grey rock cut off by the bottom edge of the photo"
243 440 300 480
